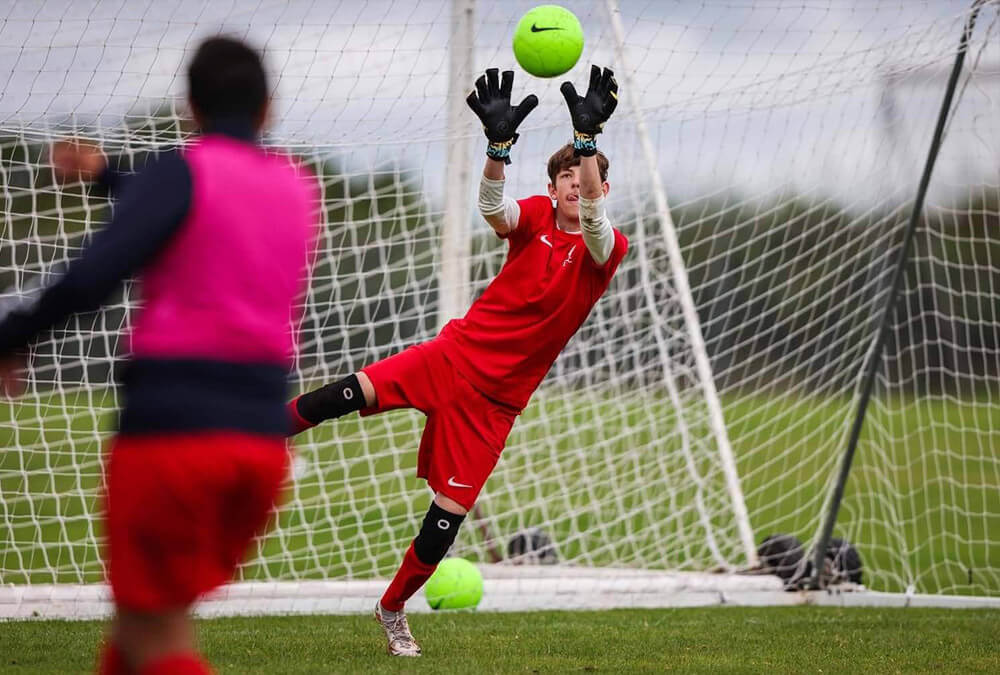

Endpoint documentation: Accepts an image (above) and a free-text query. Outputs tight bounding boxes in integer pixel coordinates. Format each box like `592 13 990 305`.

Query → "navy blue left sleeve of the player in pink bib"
0 152 192 355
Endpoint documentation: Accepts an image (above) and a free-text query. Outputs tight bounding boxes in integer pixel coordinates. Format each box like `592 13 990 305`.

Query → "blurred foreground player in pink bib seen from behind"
0 38 319 675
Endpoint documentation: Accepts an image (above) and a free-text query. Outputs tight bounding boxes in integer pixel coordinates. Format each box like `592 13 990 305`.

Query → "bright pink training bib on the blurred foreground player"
131 136 319 364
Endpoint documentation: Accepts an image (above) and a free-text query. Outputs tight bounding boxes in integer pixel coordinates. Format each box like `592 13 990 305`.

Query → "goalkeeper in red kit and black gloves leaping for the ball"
290 66 628 656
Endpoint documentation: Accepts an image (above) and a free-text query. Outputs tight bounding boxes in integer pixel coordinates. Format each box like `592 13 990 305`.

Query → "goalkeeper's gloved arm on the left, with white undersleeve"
466 68 538 235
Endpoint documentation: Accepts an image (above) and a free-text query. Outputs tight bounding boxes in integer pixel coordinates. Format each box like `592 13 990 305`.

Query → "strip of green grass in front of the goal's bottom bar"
0 607 1000 674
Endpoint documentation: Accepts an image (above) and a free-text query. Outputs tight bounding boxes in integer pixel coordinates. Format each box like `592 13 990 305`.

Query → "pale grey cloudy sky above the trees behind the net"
0 0 1000 203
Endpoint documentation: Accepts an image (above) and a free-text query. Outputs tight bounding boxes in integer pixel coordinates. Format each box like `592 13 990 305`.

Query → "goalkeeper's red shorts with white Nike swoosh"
361 340 520 509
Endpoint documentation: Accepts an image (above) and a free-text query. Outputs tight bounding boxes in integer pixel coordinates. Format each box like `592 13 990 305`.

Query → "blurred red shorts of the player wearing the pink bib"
105 432 288 612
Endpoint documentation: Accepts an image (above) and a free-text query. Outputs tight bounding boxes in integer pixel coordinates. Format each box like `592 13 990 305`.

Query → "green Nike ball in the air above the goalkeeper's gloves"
514 5 583 77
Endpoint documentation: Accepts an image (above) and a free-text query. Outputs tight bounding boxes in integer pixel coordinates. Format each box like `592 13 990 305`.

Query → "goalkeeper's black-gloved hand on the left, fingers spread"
465 68 538 164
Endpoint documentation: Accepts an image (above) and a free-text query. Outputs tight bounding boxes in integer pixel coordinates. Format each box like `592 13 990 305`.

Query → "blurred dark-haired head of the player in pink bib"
188 36 268 120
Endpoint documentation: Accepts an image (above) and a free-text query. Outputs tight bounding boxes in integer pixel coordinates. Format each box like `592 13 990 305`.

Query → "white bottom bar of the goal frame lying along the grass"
7 564 1000 622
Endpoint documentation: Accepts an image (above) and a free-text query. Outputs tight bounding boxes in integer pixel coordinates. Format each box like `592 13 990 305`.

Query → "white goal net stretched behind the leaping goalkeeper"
0 0 1000 612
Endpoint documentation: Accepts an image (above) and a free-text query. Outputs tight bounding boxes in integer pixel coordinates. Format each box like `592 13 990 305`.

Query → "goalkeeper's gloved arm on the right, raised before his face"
560 66 618 265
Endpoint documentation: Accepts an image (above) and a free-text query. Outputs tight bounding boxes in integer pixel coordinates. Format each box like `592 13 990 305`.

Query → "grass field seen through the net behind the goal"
0 390 1000 595
